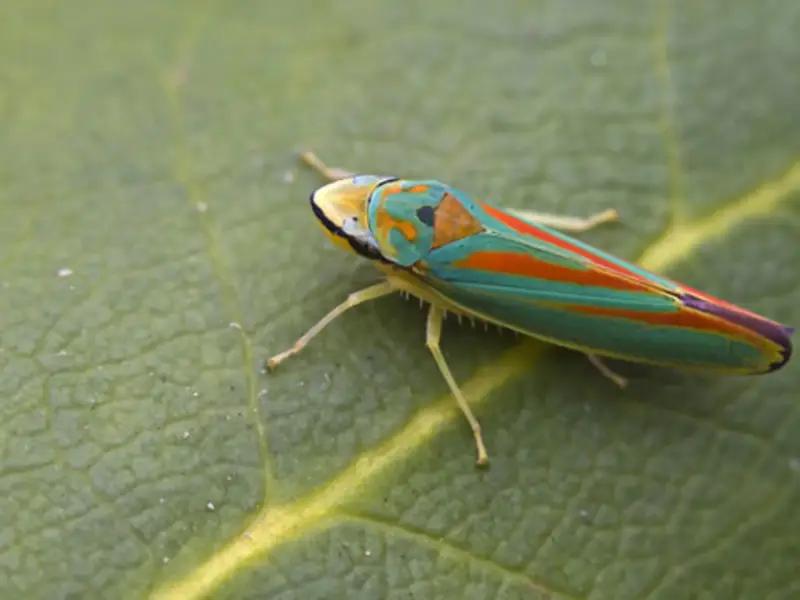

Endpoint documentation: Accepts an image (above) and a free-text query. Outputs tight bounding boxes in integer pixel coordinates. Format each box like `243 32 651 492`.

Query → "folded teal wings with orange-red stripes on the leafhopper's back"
421 194 791 373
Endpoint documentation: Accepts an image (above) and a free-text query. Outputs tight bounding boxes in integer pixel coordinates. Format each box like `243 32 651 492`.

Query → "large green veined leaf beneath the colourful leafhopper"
0 0 800 600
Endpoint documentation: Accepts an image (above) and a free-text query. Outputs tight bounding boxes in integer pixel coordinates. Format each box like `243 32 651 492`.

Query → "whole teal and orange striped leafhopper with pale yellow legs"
267 153 793 464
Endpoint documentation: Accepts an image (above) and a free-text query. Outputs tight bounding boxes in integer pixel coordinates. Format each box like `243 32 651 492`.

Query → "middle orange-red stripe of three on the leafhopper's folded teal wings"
455 250 652 292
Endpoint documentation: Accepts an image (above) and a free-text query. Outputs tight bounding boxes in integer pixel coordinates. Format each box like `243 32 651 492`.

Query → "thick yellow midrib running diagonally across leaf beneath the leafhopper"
151 162 800 600
